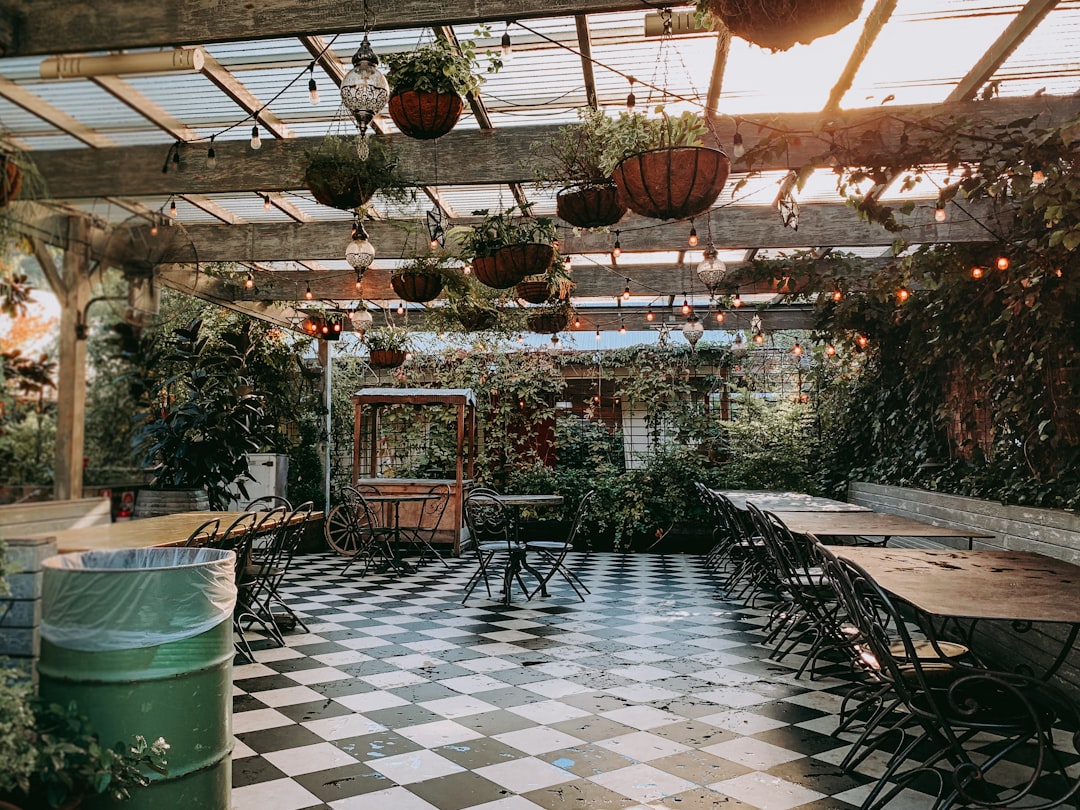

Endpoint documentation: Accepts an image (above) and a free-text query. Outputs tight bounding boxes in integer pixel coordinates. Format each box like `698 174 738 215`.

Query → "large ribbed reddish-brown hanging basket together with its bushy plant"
602 105 731 219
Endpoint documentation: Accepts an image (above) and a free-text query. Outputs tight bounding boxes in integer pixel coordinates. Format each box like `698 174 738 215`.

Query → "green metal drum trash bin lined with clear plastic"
38 549 237 810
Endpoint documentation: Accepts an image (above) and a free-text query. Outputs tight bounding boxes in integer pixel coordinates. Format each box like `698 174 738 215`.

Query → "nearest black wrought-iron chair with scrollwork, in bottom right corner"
828 557 1080 810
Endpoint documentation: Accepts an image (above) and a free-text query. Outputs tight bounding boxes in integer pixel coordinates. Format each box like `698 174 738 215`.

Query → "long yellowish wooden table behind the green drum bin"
31 512 323 554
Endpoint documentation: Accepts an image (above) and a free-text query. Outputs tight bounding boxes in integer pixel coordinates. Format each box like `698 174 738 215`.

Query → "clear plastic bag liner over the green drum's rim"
41 548 237 651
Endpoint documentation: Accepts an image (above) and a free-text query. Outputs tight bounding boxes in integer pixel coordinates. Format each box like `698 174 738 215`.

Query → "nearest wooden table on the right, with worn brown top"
833 546 1080 679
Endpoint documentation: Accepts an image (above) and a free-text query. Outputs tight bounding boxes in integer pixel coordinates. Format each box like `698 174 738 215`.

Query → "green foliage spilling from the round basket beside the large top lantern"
382 28 502 96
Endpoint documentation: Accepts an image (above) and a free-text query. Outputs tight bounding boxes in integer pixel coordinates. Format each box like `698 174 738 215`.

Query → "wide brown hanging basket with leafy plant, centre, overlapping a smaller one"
451 204 557 289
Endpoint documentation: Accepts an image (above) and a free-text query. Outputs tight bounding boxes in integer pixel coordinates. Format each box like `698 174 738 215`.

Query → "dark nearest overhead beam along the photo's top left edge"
3 0 647 56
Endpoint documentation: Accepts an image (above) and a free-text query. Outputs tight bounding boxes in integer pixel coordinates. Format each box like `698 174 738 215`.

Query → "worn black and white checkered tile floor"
225 554 1045 810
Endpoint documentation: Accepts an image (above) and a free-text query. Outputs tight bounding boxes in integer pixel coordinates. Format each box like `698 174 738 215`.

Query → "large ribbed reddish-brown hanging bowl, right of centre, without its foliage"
613 146 731 219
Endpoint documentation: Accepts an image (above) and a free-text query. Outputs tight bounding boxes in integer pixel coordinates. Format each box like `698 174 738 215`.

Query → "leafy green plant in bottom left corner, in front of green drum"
0 670 168 810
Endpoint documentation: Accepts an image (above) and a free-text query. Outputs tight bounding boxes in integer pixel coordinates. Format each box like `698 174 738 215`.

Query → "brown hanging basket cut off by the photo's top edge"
706 0 863 51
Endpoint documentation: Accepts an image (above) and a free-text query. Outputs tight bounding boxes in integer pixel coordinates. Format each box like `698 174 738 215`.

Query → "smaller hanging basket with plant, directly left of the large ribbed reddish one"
532 107 626 228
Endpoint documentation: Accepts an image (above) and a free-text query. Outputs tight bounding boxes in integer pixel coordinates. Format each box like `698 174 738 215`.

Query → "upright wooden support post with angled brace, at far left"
33 218 90 500
